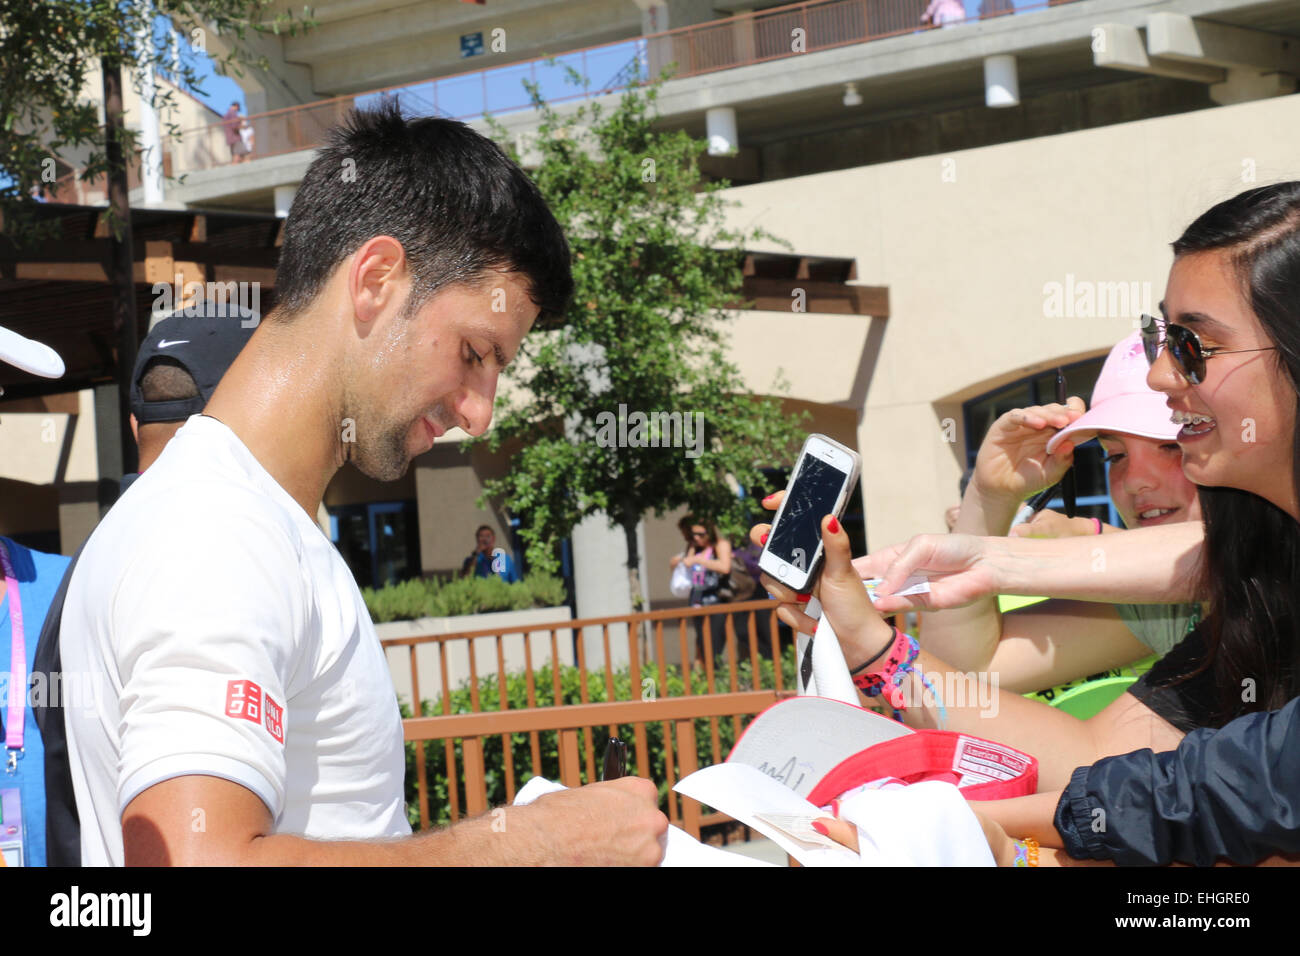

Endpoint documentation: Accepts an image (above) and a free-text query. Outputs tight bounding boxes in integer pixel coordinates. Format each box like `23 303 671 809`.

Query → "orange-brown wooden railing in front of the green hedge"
382 600 794 831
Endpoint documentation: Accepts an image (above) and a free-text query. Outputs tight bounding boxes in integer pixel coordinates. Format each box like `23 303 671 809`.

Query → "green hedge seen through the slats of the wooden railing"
402 645 794 827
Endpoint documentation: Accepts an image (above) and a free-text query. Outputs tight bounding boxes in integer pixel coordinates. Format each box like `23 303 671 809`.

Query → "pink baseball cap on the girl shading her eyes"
1048 332 1182 453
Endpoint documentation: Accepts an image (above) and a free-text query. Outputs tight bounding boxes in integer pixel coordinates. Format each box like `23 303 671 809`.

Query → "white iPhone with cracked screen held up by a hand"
758 434 862 591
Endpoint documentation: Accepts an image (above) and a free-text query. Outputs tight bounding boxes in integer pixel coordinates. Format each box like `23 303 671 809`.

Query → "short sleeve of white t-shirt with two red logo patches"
112 503 307 819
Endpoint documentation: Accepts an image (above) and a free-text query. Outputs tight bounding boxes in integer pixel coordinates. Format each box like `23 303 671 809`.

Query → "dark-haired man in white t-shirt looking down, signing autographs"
64 105 667 865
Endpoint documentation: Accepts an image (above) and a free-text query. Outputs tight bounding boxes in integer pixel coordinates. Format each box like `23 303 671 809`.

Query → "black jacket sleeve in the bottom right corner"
1056 697 1300 866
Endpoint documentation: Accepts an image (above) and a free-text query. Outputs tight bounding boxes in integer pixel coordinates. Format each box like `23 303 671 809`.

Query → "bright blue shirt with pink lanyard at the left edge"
0 538 72 866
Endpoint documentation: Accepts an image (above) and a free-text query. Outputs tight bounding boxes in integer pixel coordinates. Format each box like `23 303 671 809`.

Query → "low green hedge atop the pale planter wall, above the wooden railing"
361 574 566 624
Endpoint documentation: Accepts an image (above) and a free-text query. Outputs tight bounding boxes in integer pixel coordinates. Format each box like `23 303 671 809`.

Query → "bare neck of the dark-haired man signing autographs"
204 316 343 520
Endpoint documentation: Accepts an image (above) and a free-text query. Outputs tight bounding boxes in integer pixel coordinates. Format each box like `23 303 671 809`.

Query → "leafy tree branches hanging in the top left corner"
0 0 311 239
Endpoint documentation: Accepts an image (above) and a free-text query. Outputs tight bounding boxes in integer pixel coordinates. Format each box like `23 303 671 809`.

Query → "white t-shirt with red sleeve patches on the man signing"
61 415 411 865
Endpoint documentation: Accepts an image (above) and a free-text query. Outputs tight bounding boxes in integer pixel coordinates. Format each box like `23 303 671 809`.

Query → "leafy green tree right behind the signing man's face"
485 72 802 609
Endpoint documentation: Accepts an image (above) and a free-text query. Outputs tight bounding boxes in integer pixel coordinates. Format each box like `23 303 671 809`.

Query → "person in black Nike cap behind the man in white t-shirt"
33 307 257 866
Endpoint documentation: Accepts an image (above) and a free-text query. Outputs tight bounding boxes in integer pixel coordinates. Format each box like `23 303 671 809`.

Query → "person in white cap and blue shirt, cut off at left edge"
0 328 68 866
